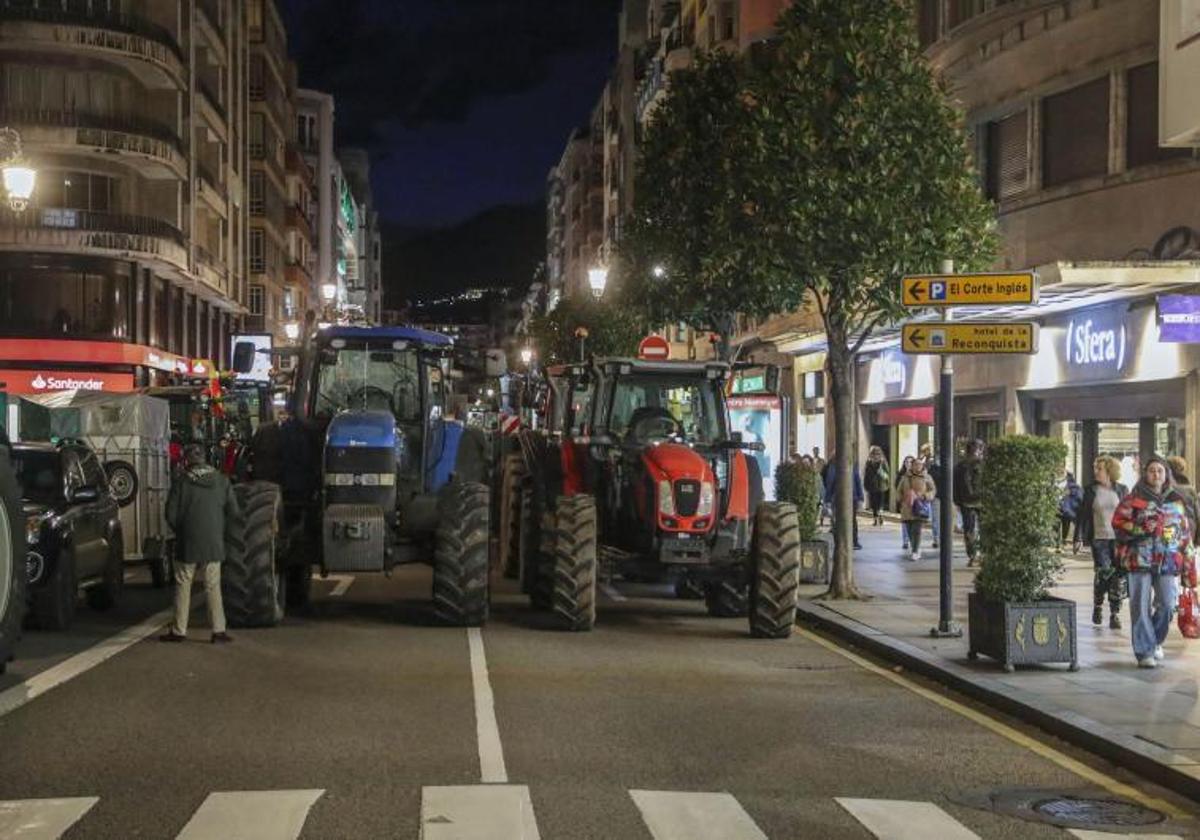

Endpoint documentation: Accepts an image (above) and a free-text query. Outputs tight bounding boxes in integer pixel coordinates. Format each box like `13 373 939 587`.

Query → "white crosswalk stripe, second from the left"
176 791 325 840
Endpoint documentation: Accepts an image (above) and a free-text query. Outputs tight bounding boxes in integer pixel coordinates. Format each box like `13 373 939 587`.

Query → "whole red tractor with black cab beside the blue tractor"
499 359 799 638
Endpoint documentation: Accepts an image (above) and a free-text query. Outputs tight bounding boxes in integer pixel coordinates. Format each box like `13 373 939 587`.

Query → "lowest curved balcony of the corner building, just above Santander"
0 208 187 271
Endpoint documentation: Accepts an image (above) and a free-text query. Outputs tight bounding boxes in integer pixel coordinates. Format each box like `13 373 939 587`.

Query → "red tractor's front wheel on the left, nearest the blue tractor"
551 496 596 631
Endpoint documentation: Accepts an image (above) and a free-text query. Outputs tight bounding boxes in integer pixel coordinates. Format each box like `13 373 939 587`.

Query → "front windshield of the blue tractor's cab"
313 344 421 422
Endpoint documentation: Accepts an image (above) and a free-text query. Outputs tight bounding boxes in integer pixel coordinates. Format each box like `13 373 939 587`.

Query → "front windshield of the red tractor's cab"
608 374 725 444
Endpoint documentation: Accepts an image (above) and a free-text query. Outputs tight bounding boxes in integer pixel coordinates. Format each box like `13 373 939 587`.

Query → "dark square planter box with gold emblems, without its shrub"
967 592 1079 672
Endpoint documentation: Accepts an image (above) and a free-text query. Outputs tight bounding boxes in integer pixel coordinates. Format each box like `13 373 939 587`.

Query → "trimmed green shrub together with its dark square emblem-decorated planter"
967 436 1079 671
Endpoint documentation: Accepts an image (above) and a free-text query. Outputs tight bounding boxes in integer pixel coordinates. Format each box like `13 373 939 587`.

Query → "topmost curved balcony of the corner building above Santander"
0 0 184 89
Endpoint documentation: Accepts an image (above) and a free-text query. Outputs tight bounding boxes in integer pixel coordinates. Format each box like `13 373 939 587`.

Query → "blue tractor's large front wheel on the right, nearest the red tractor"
433 484 491 628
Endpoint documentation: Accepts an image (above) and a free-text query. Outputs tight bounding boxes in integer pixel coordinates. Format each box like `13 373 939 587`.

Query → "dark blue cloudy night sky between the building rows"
282 0 620 228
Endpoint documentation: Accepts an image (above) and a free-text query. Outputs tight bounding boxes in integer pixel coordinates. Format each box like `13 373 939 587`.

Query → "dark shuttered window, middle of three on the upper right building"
1042 76 1109 187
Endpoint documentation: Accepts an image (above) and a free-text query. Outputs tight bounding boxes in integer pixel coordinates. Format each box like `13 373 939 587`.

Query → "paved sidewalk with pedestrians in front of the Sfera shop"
799 520 1200 799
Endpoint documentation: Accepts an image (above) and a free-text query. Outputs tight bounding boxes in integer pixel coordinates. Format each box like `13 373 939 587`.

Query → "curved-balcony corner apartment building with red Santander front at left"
0 0 248 392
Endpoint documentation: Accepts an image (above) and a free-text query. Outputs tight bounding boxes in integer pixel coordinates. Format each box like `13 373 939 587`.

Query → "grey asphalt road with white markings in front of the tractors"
0 568 1196 840
